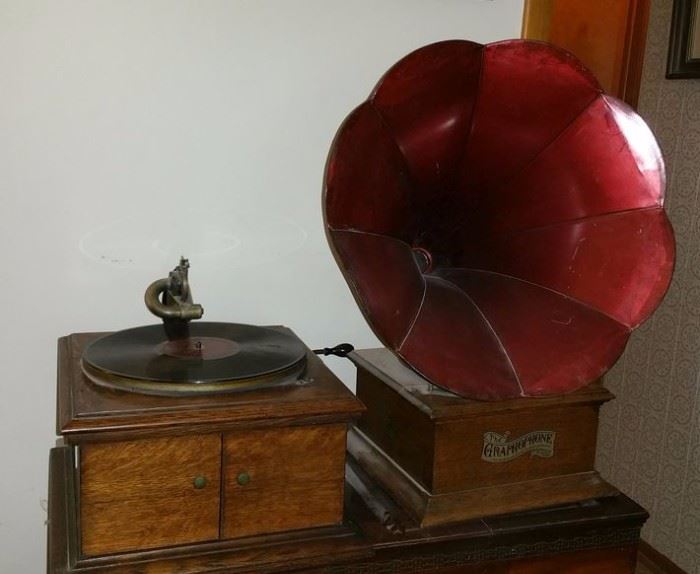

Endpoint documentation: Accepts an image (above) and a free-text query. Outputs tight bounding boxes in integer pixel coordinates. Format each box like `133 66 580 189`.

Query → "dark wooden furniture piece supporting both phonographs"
48 447 647 574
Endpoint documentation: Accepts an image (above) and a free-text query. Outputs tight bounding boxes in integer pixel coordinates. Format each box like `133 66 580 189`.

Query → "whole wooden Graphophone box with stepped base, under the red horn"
348 349 617 526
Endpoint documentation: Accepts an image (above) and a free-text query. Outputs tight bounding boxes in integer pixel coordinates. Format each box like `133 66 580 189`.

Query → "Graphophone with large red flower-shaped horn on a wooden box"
324 40 674 525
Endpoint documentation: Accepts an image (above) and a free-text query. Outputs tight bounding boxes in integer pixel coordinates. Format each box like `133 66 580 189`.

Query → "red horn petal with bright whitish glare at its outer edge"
480 96 665 233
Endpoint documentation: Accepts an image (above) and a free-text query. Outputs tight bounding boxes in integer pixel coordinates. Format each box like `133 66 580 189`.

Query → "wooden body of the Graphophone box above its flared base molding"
352 349 613 500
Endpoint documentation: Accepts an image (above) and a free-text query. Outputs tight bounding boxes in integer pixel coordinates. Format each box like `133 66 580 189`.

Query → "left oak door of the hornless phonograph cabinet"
80 434 221 556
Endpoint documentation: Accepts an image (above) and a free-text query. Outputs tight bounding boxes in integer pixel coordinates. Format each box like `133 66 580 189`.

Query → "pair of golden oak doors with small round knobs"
80 424 346 556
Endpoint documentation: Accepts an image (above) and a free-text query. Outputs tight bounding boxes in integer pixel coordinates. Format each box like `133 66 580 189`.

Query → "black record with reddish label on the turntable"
82 322 306 395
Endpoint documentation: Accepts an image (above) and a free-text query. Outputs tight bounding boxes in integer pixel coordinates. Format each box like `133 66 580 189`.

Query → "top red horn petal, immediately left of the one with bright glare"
461 41 601 196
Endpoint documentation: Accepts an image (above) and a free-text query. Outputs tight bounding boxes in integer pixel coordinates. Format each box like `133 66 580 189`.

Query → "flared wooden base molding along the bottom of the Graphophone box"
348 428 617 526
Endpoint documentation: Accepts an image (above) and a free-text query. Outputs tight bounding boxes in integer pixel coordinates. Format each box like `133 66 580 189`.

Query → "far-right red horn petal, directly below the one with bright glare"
460 207 675 329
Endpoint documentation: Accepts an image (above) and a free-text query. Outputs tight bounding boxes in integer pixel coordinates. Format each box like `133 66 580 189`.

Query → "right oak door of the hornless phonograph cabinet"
221 425 346 538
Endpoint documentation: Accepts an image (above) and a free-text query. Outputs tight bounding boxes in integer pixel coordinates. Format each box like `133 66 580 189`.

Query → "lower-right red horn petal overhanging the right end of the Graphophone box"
441 269 629 396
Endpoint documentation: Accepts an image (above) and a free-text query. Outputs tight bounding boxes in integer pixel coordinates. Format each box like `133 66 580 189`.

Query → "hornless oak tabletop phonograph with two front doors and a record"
49 258 362 572
